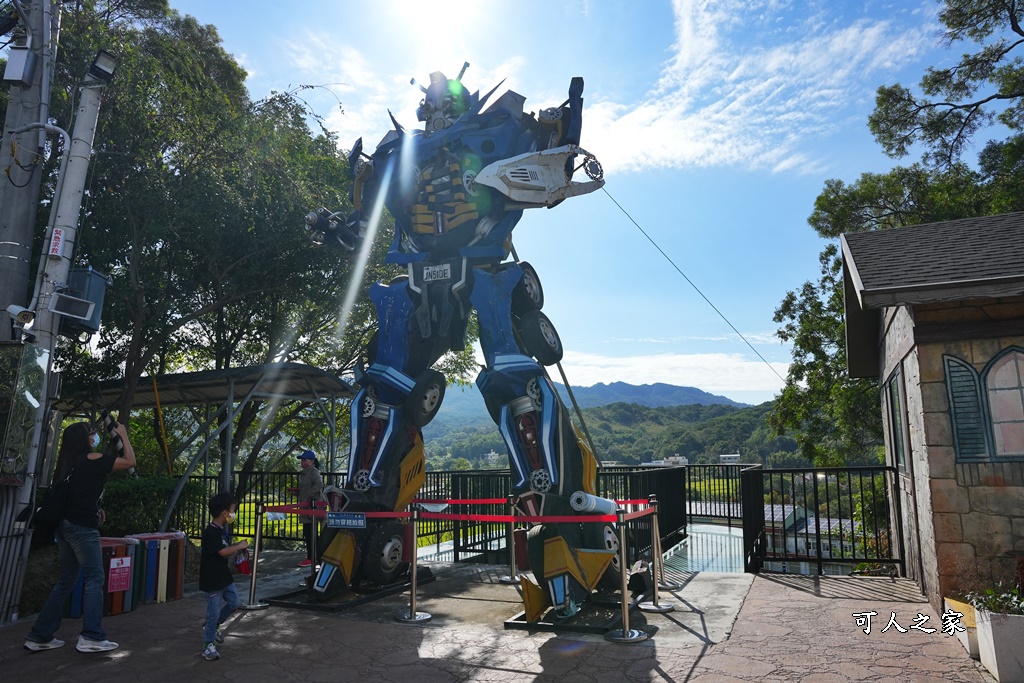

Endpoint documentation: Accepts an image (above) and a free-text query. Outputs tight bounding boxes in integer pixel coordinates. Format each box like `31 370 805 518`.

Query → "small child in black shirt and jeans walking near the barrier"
199 492 249 660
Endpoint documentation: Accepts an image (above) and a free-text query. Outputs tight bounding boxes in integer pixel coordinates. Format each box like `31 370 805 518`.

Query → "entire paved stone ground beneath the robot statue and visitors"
0 554 992 683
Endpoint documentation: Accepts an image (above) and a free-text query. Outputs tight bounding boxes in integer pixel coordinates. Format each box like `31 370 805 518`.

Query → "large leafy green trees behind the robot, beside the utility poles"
34 0 472 488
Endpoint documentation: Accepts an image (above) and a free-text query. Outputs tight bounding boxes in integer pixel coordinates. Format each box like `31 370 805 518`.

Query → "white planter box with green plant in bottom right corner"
967 584 1024 683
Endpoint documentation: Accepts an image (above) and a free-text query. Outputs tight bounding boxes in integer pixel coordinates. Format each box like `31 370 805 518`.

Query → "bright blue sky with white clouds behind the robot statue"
171 0 950 403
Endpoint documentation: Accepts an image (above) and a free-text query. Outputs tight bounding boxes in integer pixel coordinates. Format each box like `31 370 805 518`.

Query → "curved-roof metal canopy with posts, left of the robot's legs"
54 362 355 530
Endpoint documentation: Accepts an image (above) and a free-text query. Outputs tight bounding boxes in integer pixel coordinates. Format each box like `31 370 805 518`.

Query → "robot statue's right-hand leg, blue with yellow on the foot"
471 264 617 621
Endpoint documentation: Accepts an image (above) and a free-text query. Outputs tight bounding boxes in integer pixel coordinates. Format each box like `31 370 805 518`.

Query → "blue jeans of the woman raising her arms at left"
28 519 106 643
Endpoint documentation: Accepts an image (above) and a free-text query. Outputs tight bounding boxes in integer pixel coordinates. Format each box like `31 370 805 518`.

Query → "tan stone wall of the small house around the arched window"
883 298 1024 611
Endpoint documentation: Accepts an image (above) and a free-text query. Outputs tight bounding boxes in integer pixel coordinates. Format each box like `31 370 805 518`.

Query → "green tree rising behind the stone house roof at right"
769 0 1024 465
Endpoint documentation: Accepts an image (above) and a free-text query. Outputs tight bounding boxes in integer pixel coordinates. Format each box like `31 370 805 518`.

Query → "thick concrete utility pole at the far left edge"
0 0 60 342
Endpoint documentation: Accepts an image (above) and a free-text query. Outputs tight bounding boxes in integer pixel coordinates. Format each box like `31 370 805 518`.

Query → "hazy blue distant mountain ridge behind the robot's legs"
423 382 746 439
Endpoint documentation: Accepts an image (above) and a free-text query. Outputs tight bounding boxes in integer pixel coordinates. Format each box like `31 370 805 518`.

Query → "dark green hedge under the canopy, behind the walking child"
100 476 205 537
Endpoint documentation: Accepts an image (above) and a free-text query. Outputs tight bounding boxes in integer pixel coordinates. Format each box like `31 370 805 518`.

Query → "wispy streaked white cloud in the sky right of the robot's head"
586 0 933 173
